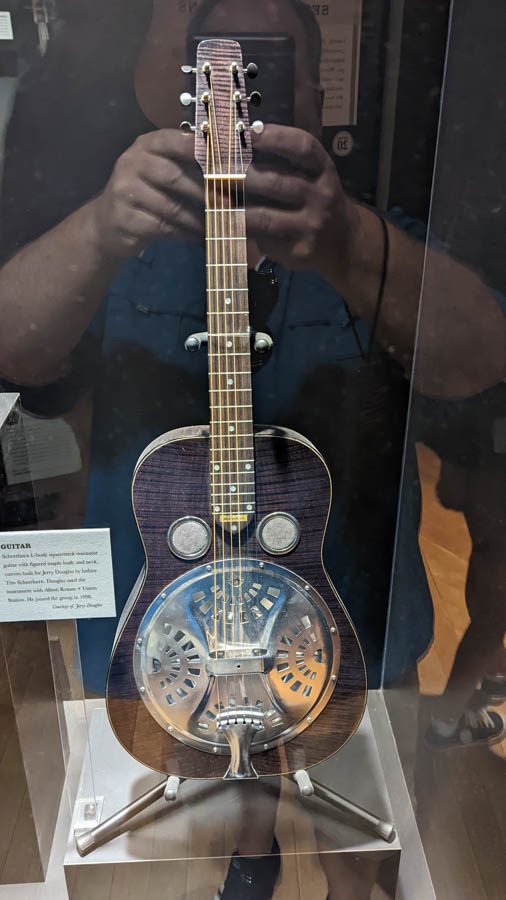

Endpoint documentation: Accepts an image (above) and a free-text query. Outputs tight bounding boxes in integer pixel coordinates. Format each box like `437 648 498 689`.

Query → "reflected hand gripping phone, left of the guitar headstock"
94 129 204 258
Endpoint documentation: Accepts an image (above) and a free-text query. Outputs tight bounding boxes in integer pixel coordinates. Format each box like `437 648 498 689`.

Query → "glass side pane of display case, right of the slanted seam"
384 4 506 898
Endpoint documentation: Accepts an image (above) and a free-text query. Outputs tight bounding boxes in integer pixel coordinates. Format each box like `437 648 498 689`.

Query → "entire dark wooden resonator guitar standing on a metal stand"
107 39 366 779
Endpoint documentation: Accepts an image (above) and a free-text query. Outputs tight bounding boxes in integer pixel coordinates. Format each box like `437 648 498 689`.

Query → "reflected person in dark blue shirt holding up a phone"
0 0 504 724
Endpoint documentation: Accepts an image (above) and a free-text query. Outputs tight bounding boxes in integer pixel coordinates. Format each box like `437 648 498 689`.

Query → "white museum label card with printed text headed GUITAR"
0 528 116 622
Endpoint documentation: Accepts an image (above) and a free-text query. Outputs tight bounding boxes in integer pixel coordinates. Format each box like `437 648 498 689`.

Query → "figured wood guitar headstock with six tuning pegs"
181 38 263 177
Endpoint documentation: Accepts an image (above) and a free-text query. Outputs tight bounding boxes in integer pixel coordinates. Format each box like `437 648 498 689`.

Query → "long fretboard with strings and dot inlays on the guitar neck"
206 179 255 531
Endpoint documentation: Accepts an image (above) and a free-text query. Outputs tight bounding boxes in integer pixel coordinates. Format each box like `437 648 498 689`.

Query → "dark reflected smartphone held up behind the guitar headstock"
193 32 295 125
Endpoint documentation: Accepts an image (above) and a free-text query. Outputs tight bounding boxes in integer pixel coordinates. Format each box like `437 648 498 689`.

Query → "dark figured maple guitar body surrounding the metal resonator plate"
107 427 366 778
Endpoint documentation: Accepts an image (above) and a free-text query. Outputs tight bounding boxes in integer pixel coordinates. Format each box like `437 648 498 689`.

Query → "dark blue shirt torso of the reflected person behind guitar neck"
82 241 412 677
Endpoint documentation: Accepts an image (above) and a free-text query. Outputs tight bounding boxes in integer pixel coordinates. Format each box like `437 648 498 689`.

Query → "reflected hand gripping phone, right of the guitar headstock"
246 125 358 280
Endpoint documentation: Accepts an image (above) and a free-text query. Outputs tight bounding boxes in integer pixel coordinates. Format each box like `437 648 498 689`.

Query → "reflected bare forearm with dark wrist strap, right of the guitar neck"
336 204 506 397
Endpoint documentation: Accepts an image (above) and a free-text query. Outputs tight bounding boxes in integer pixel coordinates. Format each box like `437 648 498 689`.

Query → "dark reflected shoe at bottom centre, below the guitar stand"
214 838 281 900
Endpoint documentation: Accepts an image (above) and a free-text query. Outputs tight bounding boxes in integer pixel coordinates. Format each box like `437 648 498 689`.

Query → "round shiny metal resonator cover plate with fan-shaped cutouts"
134 559 339 753
